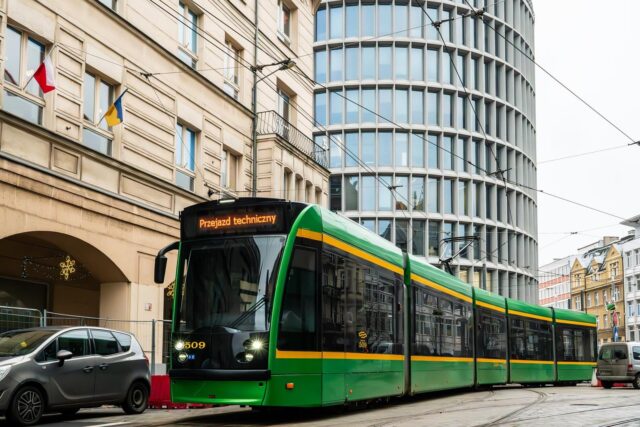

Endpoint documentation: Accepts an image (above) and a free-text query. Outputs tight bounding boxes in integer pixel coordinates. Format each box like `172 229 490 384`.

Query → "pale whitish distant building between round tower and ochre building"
538 255 576 309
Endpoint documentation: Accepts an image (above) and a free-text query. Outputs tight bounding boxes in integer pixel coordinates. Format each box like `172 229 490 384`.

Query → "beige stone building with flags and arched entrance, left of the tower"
0 0 329 370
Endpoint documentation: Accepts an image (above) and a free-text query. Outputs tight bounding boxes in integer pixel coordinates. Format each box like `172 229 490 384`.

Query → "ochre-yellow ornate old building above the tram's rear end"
571 243 626 344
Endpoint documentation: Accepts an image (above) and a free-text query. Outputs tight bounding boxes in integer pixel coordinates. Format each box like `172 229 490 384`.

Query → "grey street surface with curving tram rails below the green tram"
5 385 640 427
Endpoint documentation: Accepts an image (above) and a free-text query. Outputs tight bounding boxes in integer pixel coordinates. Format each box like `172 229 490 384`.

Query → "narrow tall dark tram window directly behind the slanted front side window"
322 252 346 351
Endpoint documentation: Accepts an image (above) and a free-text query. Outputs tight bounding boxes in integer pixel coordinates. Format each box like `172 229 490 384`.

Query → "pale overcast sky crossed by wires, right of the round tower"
533 0 640 266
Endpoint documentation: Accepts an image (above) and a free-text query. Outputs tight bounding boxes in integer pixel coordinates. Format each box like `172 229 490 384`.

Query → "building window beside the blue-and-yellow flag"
82 73 114 155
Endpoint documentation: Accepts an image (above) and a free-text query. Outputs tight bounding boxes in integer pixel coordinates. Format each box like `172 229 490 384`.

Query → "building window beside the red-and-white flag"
2 27 44 125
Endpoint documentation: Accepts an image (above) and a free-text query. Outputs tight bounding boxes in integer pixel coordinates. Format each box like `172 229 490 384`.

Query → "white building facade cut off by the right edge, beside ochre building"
621 215 640 341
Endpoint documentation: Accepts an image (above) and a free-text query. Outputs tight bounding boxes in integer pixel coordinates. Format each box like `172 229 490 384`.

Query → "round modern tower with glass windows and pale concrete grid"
314 0 538 302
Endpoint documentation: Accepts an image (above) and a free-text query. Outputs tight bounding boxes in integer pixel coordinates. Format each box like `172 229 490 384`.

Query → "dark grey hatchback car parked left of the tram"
0 327 150 425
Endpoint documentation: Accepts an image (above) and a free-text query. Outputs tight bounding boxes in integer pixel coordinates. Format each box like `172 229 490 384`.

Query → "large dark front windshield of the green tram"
177 236 285 333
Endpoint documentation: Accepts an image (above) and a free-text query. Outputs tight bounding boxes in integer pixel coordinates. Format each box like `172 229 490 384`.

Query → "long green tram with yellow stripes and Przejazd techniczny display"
155 198 596 407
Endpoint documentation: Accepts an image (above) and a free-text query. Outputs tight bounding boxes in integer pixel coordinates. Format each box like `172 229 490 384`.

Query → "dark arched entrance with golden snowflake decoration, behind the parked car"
0 231 129 317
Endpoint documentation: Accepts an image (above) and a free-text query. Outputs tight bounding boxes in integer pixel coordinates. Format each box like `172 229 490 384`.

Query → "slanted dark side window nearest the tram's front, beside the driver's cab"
278 247 317 350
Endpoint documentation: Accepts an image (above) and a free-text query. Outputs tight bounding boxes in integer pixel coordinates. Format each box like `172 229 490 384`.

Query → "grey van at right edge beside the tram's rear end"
597 342 640 389
